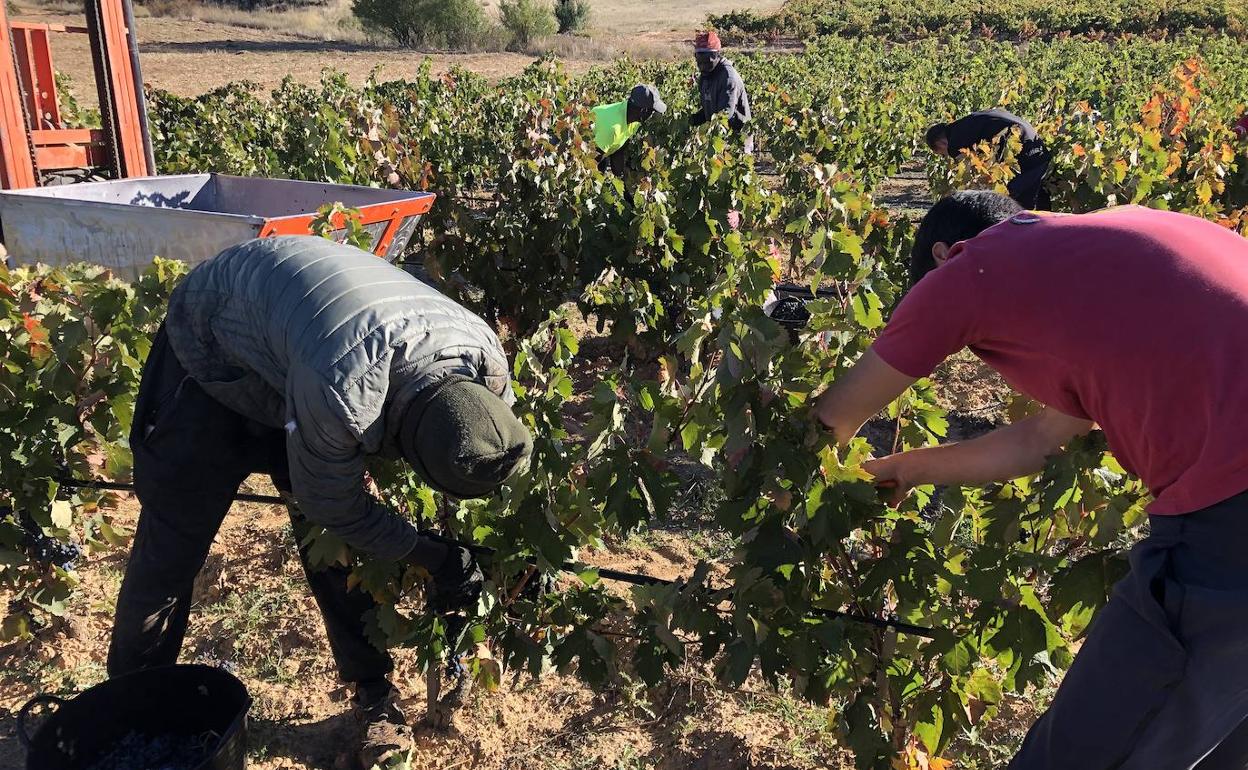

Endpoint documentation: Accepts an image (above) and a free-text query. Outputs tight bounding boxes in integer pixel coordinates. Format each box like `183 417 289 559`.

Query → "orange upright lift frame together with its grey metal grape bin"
0 0 434 277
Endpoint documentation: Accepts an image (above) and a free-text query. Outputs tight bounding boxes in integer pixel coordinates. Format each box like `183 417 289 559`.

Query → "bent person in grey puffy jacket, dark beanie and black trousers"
109 237 532 768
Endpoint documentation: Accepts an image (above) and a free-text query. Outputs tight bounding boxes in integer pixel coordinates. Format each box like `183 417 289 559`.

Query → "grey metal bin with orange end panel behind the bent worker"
0 173 434 278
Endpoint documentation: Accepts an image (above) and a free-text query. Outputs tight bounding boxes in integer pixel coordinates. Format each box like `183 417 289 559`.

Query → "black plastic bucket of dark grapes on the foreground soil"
17 665 251 770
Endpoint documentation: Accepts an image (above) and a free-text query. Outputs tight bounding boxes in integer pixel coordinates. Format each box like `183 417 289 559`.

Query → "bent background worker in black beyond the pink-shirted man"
926 107 1052 211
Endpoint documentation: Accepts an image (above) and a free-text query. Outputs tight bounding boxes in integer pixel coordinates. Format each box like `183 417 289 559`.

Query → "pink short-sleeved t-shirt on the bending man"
872 206 1248 514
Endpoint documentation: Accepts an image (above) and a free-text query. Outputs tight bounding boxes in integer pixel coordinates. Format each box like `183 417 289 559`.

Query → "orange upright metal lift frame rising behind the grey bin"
0 0 155 190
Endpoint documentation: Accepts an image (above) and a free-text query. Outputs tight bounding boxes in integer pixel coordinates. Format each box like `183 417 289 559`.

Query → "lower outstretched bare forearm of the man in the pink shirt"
864 407 1092 504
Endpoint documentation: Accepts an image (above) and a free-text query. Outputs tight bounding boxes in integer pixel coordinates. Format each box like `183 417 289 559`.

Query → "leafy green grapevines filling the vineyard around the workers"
0 26 1248 768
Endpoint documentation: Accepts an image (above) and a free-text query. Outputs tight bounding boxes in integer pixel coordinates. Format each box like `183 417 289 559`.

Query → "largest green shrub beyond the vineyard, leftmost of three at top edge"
351 0 489 47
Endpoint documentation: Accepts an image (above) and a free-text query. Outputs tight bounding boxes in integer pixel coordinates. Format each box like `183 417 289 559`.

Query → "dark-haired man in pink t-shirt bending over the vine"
816 192 1248 770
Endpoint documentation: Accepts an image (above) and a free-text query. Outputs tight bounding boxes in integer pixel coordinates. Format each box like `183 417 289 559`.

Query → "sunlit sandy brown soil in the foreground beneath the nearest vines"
0 483 847 770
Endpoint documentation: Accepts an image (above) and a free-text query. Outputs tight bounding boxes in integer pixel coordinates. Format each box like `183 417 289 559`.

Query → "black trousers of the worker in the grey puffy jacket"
109 328 393 689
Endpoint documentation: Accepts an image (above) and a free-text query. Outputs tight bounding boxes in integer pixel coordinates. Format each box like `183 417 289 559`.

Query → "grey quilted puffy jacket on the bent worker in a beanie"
165 236 514 559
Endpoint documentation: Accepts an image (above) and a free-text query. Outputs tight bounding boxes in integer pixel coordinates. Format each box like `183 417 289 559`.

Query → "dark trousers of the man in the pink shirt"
1008 492 1248 770
